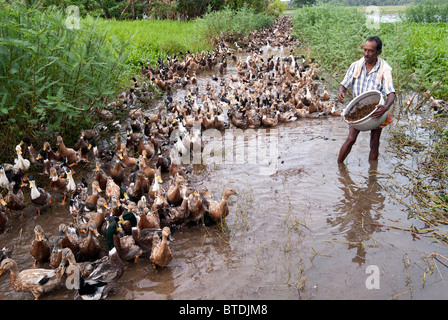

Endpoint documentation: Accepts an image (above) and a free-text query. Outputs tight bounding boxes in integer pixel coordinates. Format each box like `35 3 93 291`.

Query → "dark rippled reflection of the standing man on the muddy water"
327 161 385 265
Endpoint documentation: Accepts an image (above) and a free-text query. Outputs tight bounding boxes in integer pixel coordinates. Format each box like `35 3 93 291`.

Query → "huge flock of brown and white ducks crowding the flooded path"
0 17 340 299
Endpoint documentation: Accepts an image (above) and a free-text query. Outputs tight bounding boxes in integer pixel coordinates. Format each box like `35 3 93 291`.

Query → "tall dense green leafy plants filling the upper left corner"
0 1 130 160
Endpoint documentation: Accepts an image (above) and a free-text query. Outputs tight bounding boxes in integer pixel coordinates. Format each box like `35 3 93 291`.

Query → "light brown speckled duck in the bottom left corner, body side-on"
0 258 65 300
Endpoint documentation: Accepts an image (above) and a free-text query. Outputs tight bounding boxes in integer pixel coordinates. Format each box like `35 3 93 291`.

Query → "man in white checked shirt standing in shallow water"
338 36 395 163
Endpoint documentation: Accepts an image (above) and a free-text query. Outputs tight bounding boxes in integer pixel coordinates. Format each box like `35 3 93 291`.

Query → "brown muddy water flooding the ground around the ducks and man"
0 44 448 300
